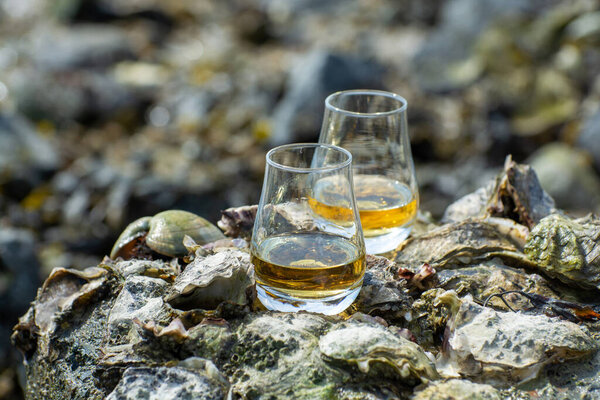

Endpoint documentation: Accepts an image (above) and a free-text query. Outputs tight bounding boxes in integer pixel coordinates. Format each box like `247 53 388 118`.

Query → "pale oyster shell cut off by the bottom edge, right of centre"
412 379 502 400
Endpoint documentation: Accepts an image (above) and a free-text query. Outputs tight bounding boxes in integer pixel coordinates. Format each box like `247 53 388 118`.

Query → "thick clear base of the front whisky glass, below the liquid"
256 280 362 315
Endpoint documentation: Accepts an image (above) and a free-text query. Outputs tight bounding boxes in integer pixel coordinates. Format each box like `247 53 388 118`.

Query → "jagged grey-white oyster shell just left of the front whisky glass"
166 248 254 310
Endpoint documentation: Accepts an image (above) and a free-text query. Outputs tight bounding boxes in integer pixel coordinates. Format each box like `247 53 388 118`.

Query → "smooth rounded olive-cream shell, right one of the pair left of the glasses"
146 210 225 257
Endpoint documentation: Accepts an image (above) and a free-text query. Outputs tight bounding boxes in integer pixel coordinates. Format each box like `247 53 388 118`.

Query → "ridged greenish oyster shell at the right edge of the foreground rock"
525 214 600 289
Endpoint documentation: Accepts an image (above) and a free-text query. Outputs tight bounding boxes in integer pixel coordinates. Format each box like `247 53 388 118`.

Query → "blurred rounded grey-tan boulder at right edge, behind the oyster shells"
528 143 600 212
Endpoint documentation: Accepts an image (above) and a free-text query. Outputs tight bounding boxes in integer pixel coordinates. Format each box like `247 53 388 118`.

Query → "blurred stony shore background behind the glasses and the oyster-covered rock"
0 0 600 399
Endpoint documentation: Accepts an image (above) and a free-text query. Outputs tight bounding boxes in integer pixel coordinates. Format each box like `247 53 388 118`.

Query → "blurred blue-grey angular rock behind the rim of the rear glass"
269 50 384 145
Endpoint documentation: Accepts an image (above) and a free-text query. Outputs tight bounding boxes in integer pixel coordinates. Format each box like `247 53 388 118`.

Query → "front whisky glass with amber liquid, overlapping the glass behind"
251 143 365 315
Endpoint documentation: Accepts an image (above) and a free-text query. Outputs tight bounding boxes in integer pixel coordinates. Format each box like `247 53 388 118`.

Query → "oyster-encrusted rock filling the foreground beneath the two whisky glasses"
12 164 600 400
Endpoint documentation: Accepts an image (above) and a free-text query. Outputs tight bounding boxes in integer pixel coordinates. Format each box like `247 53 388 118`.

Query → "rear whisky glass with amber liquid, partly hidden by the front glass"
319 90 419 254
